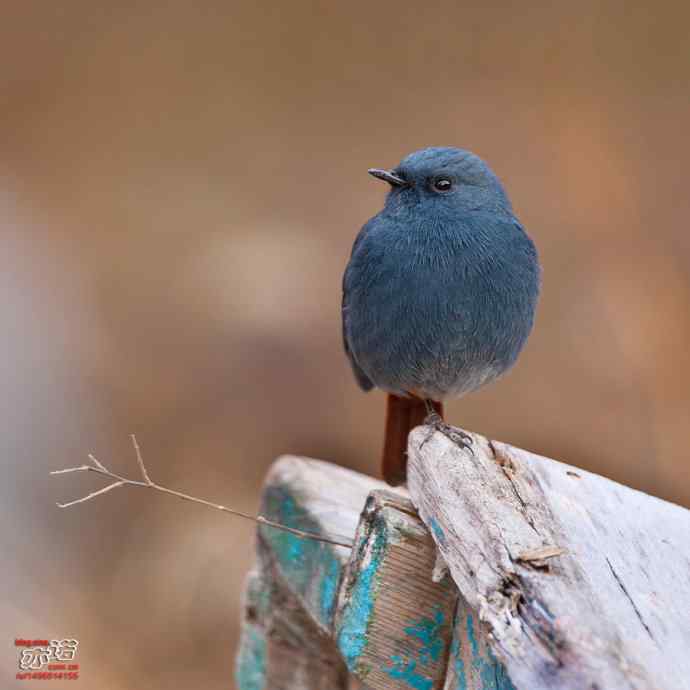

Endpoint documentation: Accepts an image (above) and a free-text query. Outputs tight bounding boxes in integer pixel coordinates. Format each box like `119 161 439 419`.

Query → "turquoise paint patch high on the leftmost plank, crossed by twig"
260 487 342 628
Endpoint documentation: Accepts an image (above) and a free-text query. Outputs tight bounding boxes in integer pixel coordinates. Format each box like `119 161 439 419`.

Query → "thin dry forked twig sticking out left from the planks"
51 434 352 548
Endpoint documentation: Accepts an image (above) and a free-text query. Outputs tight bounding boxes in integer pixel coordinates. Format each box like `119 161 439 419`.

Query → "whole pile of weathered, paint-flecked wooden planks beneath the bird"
236 427 690 690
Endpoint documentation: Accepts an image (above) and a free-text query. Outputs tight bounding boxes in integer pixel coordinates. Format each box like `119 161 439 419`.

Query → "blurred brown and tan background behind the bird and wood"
0 0 690 690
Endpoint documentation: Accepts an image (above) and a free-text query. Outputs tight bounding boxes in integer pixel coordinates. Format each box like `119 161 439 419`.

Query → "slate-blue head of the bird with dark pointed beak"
369 147 511 212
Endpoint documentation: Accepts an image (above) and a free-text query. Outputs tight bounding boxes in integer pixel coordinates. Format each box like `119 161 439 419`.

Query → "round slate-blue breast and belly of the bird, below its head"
346 211 539 399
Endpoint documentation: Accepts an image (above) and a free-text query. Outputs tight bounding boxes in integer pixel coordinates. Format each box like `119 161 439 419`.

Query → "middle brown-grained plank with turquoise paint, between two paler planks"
335 491 457 690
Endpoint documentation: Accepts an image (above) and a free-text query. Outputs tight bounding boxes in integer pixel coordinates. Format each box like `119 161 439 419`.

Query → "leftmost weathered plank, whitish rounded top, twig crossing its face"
235 457 390 690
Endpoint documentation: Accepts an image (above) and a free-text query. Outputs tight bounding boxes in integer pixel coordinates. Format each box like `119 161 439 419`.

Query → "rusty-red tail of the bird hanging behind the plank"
381 394 443 486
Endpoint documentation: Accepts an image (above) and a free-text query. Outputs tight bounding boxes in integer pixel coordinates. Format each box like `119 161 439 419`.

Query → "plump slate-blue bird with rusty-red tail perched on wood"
342 146 541 486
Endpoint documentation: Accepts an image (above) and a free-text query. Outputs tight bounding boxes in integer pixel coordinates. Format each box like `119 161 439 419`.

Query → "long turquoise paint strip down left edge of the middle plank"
338 524 387 671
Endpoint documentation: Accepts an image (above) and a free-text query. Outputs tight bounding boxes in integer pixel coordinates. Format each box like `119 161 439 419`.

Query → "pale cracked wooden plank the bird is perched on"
408 428 690 690
